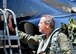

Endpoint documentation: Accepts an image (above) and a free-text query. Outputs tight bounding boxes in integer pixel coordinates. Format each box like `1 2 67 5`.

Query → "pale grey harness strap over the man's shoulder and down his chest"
37 28 59 54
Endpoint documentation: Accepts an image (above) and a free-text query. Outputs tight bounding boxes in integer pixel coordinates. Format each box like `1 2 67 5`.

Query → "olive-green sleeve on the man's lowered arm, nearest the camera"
58 33 72 54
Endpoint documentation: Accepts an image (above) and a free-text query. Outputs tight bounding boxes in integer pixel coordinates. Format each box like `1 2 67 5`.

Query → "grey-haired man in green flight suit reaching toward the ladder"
10 14 72 54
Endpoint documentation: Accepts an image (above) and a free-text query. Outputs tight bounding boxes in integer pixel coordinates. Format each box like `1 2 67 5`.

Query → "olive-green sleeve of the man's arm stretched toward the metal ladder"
18 30 41 43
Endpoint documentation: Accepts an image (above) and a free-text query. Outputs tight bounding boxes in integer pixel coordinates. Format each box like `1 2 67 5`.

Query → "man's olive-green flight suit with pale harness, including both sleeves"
19 28 72 54
